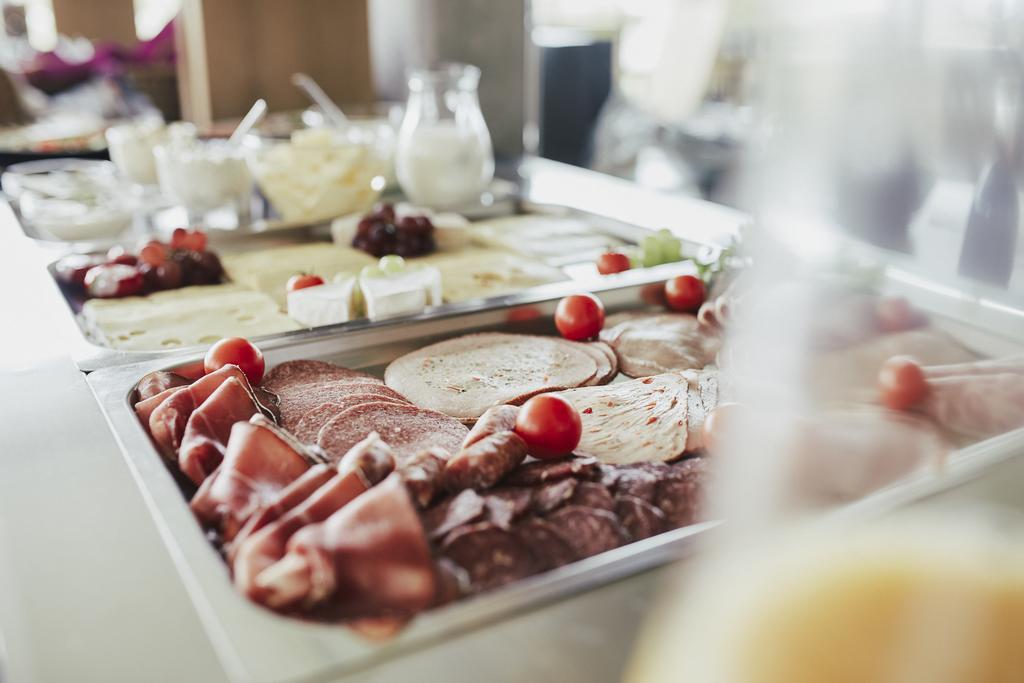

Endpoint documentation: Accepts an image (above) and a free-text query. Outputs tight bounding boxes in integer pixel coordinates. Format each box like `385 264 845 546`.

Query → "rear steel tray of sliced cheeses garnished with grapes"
34 160 742 372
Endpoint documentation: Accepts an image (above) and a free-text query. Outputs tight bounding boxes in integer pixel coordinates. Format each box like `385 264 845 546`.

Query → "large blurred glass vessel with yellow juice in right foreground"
628 0 1024 683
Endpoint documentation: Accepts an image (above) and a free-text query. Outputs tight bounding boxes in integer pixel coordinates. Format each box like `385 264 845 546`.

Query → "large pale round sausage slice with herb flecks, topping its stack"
384 333 597 420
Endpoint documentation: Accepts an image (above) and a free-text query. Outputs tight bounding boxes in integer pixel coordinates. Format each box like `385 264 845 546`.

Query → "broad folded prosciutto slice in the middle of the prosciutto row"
191 417 313 542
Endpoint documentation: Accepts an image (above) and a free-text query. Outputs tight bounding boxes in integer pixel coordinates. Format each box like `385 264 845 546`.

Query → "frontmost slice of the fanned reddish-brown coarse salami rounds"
316 401 469 467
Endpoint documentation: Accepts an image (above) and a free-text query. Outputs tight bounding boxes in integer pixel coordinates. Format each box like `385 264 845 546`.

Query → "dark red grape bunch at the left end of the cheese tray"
56 228 224 298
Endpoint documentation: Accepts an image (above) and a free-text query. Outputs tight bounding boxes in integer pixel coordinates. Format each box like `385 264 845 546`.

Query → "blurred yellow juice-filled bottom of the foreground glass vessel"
627 518 1024 683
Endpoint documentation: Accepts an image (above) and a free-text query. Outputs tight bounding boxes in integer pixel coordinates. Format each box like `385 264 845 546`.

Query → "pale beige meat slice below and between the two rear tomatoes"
601 313 722 377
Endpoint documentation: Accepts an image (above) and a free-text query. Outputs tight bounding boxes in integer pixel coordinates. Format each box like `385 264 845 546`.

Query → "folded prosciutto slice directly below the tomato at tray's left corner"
179 377 259 484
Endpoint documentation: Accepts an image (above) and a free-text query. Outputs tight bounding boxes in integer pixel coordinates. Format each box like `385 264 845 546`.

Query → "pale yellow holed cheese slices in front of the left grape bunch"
81 285 301 351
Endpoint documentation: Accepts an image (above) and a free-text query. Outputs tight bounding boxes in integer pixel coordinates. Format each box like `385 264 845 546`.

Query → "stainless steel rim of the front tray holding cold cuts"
87 264 1024 681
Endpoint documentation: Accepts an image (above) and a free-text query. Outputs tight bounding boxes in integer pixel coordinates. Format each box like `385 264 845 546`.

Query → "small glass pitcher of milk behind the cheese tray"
395 65 495 207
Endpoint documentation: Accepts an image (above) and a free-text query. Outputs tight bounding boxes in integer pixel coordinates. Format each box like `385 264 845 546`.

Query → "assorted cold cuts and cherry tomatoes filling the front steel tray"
123 258 1024 635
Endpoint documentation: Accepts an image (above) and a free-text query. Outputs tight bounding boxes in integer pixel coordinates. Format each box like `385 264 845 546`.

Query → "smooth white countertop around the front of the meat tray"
0 194 679 683
